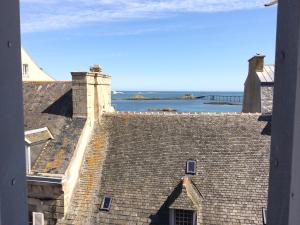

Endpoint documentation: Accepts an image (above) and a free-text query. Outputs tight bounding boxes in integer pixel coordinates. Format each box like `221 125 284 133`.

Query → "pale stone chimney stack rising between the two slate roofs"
71 65 114 120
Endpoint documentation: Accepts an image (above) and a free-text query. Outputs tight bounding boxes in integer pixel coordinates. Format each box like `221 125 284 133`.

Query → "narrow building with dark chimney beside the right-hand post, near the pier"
243 54 275 114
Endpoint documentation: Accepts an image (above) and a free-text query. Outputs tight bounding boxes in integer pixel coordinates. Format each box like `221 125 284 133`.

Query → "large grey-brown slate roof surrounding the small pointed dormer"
60 113 270 225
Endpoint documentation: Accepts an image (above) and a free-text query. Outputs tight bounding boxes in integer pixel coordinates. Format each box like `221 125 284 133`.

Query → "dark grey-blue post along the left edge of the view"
0 0 27 225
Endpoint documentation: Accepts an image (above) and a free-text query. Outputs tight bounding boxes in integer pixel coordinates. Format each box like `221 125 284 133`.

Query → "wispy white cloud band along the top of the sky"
21 0 264 32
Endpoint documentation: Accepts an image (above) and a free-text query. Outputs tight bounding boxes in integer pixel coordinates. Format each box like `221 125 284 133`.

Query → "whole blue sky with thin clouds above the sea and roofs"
21 0 277 91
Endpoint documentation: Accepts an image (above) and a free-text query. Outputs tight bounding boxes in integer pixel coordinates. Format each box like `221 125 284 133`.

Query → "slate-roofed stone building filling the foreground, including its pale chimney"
23 63 271 225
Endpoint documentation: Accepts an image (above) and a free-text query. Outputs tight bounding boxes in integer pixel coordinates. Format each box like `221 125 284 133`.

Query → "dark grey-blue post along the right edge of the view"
267 0 300 225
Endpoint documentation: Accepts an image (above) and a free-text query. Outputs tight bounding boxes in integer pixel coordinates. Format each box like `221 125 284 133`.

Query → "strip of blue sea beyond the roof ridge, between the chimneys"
112 91 243 112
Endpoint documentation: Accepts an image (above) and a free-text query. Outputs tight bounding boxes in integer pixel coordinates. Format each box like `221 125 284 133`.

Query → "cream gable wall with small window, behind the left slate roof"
21 48 54 81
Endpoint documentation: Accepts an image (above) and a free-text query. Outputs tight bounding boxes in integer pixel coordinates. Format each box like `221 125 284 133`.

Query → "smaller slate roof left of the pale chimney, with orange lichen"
23 81 85 174
